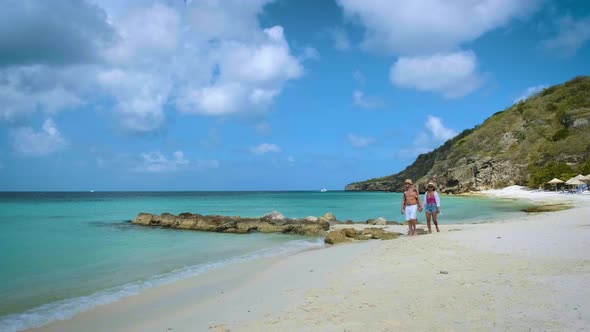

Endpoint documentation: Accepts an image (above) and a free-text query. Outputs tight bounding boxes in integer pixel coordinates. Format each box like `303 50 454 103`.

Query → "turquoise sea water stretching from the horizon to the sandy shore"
0 191 523 331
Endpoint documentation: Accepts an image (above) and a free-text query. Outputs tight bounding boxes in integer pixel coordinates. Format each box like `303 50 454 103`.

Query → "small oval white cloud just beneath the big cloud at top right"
389 51 481 98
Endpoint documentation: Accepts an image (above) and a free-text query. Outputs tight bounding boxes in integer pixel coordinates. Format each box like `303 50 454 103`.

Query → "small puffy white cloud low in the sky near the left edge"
12 119 68 157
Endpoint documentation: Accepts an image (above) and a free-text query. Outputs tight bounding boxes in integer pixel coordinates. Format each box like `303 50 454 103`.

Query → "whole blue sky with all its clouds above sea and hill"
0 0 590 191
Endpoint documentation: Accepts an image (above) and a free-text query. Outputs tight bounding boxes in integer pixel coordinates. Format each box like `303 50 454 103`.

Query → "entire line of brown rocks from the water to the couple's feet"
131 211 401 244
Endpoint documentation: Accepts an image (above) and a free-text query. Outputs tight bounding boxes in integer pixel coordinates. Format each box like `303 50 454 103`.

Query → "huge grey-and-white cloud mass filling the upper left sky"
0 0 306 132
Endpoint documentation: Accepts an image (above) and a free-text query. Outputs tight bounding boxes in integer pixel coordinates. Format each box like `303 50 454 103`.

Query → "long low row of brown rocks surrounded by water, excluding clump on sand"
132 211 335 236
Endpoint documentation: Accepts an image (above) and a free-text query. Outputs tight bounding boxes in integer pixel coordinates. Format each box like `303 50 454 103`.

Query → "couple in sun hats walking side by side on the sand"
402 179 440 236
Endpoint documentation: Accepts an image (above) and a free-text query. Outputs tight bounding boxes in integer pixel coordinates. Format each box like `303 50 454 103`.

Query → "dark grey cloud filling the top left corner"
0 0 115 66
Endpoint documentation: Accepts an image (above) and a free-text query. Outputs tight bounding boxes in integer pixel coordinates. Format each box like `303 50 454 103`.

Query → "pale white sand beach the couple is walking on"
31 187 590 331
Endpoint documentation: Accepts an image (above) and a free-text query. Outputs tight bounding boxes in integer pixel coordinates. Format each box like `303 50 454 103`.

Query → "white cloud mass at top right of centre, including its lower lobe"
337 0 540 98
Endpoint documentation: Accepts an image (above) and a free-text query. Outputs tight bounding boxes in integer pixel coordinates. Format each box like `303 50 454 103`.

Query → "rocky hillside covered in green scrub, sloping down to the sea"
345 76 590 193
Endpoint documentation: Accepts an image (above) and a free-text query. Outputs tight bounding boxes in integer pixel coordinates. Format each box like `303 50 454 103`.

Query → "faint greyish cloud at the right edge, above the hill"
543 16 590 55
